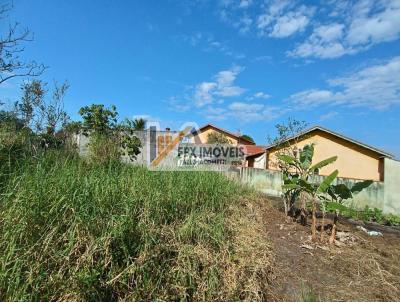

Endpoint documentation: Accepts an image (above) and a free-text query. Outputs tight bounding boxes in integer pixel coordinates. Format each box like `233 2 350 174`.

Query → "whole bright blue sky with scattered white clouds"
0 0 400 157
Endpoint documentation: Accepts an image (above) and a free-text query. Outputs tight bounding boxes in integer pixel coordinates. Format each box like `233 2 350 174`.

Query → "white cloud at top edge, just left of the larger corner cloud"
257 0 315 38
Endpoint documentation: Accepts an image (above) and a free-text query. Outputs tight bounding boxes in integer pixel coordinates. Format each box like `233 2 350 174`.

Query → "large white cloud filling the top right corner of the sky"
287 0 400 59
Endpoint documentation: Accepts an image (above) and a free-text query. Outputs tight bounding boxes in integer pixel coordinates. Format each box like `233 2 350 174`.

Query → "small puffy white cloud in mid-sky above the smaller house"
193 66 245 107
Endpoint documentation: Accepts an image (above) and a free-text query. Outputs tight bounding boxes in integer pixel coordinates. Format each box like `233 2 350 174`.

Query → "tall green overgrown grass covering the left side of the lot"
0 152 250 301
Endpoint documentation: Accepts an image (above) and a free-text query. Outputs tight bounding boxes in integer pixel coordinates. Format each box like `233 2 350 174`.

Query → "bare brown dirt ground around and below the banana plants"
263 199 400 301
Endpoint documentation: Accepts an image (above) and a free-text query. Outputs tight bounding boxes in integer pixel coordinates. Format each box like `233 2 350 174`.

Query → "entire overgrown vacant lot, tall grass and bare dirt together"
0 153 400 301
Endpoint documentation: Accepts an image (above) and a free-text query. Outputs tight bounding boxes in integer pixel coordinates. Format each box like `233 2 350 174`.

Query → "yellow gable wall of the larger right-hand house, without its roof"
268 131 383 181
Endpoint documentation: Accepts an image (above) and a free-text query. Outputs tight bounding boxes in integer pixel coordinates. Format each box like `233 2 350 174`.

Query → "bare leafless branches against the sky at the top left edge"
0 4 46 85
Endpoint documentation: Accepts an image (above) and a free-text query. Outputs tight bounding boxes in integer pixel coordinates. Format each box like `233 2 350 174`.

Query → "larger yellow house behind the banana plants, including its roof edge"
266 126 393 181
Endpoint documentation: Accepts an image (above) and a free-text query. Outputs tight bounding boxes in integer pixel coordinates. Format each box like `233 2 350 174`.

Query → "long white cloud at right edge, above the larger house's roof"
289 57 400 110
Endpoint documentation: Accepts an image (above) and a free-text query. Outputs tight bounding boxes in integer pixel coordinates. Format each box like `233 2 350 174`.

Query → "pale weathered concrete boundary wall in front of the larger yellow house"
240 166 400 215
